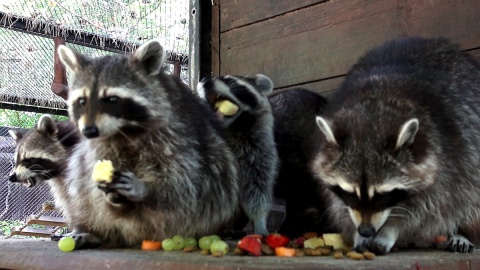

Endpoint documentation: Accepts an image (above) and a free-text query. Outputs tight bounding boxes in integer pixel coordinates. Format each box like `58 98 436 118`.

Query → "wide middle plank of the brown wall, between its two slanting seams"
220 0 480 88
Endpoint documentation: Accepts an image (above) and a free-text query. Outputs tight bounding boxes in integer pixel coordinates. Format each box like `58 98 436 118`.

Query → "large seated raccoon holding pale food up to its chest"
58 40 239 248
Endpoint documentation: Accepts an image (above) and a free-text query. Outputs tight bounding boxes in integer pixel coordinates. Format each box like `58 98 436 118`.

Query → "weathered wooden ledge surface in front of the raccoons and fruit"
0 238 480 270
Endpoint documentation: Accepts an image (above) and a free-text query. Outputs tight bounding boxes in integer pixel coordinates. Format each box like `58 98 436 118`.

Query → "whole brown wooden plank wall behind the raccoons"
212 0 480 94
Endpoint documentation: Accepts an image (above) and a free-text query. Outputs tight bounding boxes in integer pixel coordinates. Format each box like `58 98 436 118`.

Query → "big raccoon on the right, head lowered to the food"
312 37 480 254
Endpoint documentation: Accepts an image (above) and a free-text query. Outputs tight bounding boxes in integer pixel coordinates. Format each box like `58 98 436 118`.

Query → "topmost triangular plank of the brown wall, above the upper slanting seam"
220 0 326 32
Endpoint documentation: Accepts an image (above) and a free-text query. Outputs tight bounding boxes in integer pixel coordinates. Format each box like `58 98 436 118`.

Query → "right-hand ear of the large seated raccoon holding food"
130 39 166 76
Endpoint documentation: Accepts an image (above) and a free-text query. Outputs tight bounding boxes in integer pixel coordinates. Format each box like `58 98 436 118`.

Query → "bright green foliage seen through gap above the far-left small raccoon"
0 109 68 128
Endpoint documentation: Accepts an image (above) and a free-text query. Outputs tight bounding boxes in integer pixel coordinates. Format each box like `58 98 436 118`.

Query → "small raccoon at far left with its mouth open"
9 115 80 220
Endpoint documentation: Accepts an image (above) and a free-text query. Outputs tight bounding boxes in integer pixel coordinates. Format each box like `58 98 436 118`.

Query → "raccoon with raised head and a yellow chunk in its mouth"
197 74 278 235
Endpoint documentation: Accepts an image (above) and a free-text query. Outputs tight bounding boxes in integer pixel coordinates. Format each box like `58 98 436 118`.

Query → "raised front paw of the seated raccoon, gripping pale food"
102 171 147 202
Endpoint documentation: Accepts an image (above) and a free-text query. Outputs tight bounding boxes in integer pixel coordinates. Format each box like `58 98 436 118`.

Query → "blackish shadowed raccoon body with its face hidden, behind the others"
269 88 331 237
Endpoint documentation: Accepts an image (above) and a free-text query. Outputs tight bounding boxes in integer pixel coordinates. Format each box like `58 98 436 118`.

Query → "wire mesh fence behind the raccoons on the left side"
0 0 189 235
